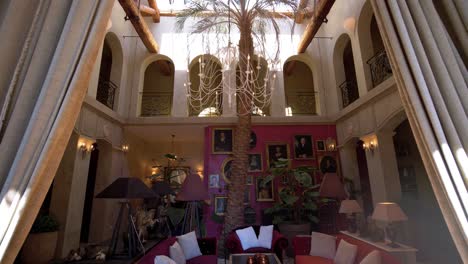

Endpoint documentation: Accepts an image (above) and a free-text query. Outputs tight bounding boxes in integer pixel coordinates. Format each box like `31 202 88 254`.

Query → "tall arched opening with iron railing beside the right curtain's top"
358 1 392 90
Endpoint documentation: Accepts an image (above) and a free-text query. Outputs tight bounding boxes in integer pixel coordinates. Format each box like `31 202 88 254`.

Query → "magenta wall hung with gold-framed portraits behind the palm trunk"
204 124 339 235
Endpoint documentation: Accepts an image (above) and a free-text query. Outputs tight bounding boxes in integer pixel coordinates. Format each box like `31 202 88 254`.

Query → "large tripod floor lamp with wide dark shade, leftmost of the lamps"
96 177 157 258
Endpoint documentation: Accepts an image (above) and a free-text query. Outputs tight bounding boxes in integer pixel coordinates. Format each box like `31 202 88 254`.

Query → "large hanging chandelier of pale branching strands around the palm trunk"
184 0 279 116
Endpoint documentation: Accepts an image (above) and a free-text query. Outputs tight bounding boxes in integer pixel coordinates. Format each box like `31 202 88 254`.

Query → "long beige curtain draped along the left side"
0 0 114 263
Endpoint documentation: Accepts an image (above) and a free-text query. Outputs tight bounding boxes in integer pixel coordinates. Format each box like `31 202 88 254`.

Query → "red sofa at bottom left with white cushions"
136 237 218 264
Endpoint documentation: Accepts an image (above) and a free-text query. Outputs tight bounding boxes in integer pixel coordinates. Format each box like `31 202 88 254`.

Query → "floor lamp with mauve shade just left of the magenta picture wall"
176 174 210 237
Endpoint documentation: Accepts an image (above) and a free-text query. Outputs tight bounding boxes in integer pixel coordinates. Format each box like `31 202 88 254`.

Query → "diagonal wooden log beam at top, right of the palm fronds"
297 0 335 53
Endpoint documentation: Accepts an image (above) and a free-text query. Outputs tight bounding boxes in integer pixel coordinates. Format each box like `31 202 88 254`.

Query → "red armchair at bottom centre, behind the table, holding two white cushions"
226 226 288 261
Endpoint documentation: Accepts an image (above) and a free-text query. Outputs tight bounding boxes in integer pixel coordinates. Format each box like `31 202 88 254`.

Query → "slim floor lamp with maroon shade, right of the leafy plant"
319 173 346 234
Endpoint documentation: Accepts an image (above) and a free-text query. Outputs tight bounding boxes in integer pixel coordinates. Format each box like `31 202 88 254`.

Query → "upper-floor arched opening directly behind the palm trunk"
236 55 270 116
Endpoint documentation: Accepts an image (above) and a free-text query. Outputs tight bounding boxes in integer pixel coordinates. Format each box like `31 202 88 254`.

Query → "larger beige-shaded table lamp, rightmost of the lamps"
372 202 408 248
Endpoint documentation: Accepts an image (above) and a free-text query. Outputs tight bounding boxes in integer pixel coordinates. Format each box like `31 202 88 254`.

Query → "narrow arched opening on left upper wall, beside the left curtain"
96 32 123 110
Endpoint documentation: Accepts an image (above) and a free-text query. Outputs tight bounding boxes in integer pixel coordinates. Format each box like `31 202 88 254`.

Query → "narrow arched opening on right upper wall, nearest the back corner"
333 34 359 108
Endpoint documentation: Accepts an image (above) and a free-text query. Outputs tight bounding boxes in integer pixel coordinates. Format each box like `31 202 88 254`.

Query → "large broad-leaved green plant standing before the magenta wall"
262 160 320 224
